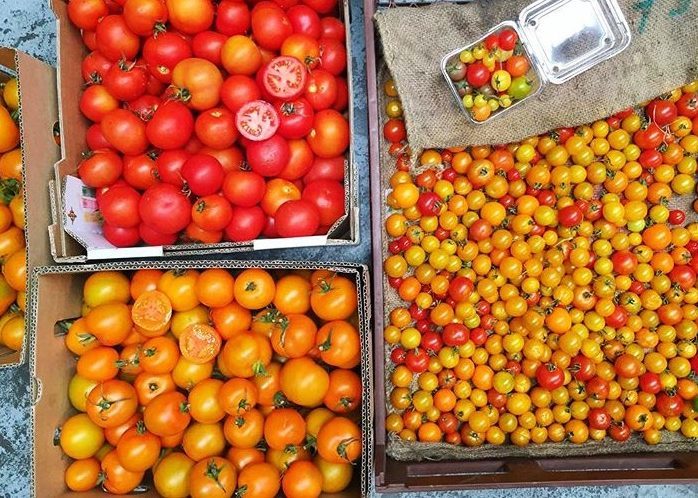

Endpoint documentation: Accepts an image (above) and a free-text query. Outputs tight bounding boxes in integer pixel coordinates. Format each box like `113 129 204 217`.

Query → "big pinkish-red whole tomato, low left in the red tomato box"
138 183 191 235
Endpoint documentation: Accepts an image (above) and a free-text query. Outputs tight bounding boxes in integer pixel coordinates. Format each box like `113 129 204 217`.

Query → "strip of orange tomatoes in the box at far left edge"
0 78 27 351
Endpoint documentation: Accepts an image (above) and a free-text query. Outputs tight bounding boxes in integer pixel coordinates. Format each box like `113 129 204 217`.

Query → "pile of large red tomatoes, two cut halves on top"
68 0 350 247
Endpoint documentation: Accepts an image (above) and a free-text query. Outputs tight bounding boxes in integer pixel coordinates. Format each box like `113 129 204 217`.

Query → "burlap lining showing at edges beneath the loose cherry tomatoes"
375 61 698 461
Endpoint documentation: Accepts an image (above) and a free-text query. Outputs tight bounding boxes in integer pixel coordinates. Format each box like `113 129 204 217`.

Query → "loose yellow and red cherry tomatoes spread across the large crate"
384 81 698 446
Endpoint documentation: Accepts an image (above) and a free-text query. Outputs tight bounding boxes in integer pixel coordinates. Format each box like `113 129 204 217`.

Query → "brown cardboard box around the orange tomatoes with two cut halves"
28 260 373 498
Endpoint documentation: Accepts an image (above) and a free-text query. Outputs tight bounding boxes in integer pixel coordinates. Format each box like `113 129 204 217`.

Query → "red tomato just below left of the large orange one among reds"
145 100 194 149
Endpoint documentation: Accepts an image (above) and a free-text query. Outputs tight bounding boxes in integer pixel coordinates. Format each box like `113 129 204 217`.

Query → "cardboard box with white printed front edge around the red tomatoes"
50 0 363 263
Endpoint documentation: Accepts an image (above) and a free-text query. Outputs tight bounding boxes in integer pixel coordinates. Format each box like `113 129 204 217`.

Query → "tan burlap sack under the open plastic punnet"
375 0 698 151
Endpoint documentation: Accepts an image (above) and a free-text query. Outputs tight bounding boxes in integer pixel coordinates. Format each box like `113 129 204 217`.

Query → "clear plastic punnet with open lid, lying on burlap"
441 0 631 125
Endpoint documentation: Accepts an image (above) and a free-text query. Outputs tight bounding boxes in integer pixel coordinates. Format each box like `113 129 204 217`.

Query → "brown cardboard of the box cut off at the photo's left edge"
0 47 60 368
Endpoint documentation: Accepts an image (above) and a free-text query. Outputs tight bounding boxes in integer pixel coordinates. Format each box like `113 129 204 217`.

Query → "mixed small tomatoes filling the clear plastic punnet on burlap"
446 28 535 121
